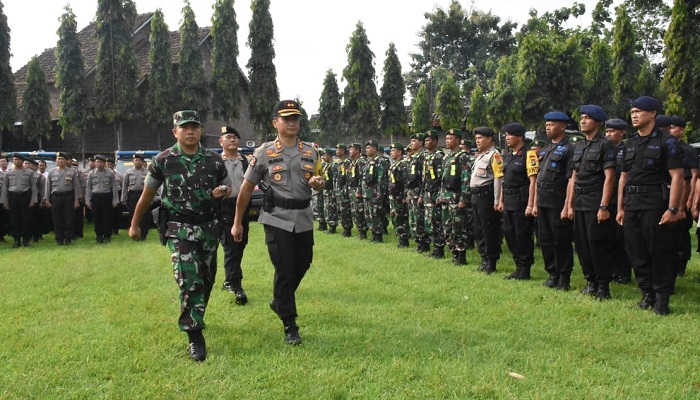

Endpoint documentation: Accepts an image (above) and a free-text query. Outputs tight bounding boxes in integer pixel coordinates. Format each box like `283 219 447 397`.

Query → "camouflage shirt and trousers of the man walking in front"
146 144 230 332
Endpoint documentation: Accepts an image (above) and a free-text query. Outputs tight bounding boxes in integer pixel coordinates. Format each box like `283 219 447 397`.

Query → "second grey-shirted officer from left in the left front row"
44 152 81 246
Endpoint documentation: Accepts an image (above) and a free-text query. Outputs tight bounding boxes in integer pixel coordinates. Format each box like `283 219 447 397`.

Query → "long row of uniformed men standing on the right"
316 96 700 315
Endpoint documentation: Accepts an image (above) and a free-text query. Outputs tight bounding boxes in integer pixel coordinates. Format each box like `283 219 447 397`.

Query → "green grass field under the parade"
0 223 700 399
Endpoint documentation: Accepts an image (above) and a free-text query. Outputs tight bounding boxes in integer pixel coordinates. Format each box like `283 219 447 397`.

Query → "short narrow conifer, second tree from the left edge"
22 56 51 148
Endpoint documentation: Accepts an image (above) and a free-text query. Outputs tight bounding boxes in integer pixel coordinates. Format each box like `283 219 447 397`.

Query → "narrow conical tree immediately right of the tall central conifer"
379 43 407 141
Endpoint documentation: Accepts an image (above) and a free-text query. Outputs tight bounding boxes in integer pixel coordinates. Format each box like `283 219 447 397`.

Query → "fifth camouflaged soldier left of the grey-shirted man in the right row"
362 140 389 243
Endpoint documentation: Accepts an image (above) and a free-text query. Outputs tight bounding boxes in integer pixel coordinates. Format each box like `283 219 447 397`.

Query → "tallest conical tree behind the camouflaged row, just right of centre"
343 22 379 141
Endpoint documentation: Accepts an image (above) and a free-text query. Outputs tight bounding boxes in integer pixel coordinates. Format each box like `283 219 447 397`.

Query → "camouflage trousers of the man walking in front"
168 237 219 331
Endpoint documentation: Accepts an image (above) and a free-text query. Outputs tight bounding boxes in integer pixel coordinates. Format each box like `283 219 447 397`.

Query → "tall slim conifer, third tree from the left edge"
55 6 93 142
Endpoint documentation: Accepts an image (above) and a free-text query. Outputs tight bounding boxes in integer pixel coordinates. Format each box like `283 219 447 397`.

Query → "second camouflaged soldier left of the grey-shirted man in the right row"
422 130 445 259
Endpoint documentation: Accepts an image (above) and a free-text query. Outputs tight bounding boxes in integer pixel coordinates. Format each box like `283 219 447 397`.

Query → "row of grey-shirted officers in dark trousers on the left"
0 152 148 248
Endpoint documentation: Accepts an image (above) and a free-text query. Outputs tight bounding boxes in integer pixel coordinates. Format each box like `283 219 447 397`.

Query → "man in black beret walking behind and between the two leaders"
220 126 250 306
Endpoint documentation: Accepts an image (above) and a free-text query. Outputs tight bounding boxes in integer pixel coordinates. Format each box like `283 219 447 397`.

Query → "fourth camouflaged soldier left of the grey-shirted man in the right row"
389 142 410 247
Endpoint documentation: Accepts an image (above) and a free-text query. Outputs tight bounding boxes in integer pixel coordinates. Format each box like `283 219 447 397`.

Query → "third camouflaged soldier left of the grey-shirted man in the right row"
406 133 430 253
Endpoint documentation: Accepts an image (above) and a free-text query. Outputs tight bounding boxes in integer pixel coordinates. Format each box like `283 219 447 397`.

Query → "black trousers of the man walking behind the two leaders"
221 198 250 286
